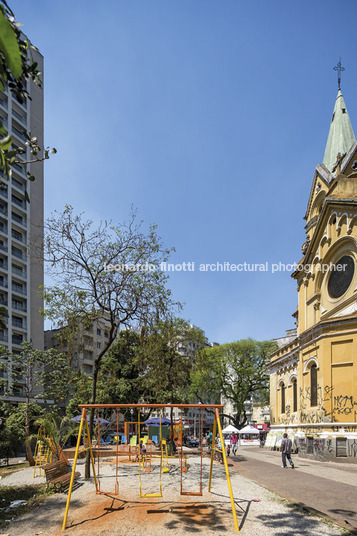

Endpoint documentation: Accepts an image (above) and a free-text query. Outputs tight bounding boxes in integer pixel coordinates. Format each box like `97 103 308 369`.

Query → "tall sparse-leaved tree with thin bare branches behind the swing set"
44 206 173 476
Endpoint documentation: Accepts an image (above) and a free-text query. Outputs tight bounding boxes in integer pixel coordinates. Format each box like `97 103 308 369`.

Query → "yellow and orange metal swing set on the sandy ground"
62 404 239 532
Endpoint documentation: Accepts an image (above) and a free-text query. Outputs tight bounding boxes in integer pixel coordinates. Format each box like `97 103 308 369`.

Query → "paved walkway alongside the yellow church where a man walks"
228 447 357 534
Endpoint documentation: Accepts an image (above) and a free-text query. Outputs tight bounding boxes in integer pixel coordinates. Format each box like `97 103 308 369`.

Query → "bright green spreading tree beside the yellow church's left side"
191 339 276 428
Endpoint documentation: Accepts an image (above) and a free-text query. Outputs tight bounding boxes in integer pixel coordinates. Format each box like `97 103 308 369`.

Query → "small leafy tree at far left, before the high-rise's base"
2 341 71 465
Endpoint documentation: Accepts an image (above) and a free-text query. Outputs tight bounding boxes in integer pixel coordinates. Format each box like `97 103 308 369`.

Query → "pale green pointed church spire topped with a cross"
323 58 356 172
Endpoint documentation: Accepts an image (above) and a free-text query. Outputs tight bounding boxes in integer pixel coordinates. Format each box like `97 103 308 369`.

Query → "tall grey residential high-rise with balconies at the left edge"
0 44 44 401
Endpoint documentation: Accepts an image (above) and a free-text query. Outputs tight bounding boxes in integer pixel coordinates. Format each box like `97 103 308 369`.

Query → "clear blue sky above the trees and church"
10 0 357 343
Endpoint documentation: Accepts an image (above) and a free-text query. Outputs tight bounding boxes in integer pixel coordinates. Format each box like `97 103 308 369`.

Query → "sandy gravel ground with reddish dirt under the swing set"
0 456 342 536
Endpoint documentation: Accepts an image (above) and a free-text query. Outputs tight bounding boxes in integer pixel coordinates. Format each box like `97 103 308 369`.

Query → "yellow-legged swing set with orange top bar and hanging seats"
62 404 239 532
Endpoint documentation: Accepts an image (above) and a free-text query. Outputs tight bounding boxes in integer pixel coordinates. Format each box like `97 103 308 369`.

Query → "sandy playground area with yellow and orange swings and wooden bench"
0 404 348 536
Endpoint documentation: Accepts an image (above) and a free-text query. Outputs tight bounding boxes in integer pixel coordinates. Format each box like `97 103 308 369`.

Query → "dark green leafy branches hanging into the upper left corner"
0 0 56 193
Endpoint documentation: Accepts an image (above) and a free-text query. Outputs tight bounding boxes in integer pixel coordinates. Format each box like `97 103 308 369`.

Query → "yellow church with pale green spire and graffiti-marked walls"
266 62 357 463
